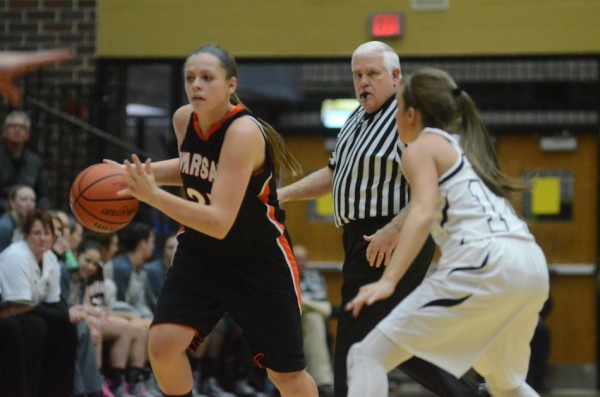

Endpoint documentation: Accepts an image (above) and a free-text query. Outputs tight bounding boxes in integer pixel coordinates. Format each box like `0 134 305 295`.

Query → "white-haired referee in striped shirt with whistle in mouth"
278 41 488 397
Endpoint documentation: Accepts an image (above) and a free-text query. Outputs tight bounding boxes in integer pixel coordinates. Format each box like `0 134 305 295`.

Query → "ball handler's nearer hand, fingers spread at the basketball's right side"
118 154 159 205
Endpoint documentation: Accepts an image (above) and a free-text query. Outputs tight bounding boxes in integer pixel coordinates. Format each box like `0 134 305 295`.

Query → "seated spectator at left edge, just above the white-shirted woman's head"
0 185 35 251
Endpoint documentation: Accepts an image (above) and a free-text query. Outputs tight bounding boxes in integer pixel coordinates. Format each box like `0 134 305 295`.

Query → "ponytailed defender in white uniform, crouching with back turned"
346 69 549 397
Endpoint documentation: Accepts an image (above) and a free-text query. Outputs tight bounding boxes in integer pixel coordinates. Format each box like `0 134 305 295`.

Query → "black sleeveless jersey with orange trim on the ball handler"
179 105 285 256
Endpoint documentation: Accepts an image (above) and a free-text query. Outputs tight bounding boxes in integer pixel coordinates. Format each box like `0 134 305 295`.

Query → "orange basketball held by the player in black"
69 163 139 233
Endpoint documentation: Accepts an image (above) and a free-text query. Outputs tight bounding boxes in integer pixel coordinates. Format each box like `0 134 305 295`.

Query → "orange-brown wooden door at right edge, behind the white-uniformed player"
497 134 598 364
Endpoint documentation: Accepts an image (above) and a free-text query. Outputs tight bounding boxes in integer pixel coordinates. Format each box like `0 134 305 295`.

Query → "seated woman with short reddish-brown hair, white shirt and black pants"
0 209 77 397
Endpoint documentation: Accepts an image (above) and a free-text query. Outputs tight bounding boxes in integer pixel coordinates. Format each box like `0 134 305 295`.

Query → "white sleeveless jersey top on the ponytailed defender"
422 128 534 253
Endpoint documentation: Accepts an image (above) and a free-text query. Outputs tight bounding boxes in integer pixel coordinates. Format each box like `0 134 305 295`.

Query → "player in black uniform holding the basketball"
115 45 317 397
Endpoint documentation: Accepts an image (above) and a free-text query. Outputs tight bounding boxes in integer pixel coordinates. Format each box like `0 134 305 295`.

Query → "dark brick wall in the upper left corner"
0 0 99 210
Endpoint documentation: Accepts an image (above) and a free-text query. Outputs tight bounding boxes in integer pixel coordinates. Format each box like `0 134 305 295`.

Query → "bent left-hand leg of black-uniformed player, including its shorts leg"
148 238 225 396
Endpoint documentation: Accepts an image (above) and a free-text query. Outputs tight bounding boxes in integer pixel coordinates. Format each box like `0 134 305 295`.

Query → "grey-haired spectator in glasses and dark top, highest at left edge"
0 111 51 213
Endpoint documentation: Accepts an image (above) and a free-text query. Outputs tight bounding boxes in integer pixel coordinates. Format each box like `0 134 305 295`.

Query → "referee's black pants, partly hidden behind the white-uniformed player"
333 218 479 397
